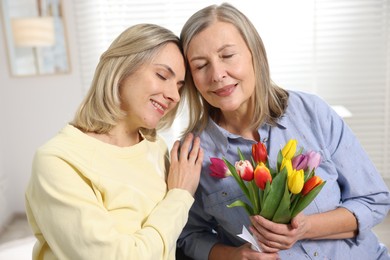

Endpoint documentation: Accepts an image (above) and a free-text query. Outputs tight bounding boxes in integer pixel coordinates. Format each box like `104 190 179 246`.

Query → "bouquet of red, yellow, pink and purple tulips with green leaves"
210 139 326 224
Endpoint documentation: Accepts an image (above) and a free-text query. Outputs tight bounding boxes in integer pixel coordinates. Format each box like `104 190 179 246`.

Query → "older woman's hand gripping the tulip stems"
250 213 310 252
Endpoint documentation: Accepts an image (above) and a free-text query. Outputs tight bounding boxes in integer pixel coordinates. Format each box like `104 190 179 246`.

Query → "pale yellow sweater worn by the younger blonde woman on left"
26 125 194 260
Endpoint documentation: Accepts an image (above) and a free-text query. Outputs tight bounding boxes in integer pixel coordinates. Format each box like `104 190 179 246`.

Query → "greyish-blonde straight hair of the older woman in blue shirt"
180 3 288 133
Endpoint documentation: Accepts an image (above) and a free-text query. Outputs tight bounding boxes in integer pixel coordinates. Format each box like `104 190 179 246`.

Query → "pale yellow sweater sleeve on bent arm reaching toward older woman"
26 150 194 259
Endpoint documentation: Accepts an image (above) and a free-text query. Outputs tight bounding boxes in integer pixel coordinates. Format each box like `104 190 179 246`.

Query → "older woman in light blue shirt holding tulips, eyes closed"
178 4 390 260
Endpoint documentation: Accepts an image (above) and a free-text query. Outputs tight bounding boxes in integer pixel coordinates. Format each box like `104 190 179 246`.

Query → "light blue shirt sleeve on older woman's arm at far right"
317 95 390 243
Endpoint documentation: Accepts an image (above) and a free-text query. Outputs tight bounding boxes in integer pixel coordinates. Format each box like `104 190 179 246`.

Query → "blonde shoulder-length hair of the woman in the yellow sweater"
71 24 182 139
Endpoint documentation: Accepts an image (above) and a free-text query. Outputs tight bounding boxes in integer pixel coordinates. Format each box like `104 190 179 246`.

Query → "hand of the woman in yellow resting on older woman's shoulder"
167 133 203 196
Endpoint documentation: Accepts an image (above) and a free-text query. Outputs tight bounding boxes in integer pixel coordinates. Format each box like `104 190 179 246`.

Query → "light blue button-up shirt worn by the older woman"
178 91 390 260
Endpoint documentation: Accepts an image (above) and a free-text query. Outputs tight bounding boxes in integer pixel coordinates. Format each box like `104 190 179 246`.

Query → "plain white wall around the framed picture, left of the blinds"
0 1 84 229
